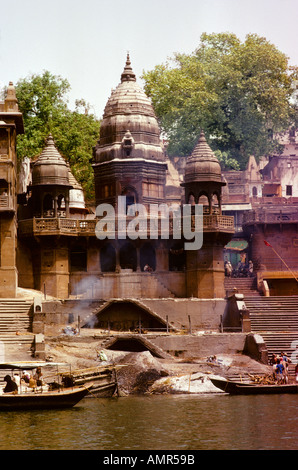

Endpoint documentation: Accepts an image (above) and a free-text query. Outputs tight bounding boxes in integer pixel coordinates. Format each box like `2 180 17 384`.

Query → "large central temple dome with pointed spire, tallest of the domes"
94 55 165 163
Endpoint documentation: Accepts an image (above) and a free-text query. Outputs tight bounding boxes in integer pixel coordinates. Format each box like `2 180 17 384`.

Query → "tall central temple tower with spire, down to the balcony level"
93 51 167 206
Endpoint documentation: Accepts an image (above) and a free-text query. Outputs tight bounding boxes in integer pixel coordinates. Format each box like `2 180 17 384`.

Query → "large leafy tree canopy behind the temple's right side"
142 33 297 168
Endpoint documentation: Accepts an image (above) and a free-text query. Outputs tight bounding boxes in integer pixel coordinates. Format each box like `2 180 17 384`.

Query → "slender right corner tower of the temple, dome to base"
182 132 234 298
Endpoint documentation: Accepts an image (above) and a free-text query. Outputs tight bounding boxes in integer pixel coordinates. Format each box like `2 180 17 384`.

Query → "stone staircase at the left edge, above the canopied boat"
0 299 34 362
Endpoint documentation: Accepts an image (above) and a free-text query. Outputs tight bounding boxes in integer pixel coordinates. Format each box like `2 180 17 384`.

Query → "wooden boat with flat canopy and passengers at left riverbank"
0 362 93 411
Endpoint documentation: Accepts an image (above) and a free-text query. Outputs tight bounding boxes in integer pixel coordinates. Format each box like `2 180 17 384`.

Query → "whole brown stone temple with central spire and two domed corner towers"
9 56 234 308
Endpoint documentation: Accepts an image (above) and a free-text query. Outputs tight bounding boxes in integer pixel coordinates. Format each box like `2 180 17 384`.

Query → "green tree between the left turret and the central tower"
15 71 100 199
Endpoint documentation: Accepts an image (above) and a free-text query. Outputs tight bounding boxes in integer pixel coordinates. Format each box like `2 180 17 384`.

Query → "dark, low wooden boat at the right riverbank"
210 377 298 395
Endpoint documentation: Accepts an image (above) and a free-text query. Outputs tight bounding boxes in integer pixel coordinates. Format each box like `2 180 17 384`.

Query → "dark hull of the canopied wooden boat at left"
0 387 89 411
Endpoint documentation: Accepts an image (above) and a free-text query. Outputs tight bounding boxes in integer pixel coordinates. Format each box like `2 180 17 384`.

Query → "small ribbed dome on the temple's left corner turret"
32 134 71 186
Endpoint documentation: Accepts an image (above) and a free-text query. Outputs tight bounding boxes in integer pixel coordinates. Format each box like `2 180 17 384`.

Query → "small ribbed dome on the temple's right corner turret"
184 131 222 183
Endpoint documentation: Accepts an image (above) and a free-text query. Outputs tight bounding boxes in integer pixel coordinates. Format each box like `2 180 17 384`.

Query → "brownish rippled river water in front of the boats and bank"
0 393 298 451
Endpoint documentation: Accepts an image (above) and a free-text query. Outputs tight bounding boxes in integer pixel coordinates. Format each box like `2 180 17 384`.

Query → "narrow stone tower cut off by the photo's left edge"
0 82 24 297
